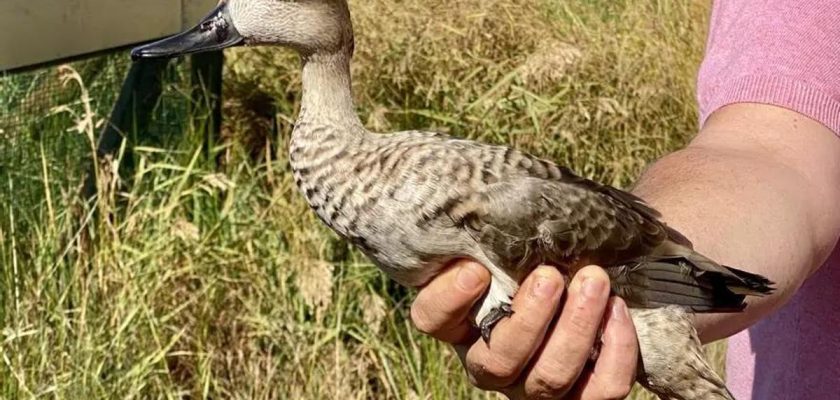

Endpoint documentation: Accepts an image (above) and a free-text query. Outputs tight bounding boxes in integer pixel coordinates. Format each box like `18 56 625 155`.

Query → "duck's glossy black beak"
131 1 245 61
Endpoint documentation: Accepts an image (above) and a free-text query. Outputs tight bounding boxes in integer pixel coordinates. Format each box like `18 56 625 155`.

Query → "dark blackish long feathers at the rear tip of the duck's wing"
608 257 772 312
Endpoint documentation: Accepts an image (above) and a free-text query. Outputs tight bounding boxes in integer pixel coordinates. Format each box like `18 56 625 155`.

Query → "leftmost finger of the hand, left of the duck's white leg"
411 260 490 343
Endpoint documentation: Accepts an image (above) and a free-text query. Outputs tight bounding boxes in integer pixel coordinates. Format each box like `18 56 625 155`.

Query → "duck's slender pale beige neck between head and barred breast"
298 51 362 131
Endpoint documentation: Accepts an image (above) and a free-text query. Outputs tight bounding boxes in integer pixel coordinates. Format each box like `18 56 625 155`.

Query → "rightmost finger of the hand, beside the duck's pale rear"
573 297 639 400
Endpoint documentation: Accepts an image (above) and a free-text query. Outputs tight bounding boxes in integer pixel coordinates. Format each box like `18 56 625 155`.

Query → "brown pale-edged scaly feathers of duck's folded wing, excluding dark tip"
452 177 670 274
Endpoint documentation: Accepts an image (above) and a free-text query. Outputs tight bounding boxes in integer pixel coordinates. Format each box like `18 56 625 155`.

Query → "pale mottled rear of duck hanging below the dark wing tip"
630 306 734 400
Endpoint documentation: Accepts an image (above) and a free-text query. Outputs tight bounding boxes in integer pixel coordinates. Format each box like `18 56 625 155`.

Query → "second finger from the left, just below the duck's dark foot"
465 267 563 389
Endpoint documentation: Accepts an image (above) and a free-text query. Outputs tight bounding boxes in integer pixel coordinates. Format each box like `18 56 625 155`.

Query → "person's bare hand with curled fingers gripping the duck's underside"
411 261 639 400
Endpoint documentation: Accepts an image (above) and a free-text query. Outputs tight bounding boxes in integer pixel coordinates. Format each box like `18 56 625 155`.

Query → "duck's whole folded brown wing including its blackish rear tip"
455 162 772 312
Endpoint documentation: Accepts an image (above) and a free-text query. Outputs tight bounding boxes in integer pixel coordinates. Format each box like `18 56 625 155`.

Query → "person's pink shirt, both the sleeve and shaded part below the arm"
697 0 840 400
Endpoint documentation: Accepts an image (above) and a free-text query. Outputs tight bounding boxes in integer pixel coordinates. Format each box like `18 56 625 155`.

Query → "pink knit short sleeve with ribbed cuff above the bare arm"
697 0 840 134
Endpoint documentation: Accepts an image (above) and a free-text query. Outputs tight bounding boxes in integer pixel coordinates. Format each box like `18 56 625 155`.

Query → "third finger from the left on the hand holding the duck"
524 266 614 398
